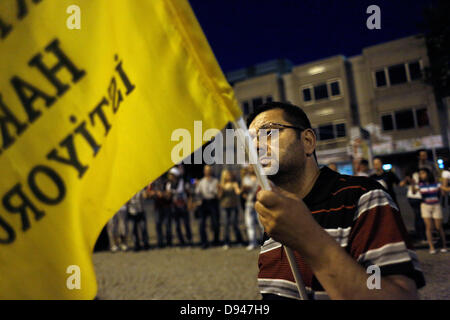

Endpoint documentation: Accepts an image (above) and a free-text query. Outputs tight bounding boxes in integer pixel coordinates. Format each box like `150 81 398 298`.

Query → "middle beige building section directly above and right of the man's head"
283 56 357 172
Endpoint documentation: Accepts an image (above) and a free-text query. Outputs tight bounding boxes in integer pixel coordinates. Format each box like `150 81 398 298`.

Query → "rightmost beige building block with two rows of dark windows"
350 37 447 164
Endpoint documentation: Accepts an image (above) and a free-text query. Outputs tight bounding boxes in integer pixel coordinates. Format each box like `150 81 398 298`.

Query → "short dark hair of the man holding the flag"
247 101 311 129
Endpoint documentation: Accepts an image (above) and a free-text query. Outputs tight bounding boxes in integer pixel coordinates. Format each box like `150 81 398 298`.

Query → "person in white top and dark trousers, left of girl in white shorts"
399 167 426 242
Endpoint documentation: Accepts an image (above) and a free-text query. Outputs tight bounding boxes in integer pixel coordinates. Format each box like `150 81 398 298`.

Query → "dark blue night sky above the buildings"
189 0 432 72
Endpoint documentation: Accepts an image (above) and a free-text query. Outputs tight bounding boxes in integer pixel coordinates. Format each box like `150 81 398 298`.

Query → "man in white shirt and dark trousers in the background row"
195 165 220 249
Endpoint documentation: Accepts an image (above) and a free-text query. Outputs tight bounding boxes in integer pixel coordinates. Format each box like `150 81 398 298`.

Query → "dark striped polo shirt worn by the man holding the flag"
258 167 425 299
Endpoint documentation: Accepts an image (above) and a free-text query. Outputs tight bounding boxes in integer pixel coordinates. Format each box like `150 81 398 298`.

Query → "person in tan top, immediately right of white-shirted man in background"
218 169 243 249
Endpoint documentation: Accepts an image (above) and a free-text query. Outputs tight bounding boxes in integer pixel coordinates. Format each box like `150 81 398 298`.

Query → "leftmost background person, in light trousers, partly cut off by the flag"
106 204 128 252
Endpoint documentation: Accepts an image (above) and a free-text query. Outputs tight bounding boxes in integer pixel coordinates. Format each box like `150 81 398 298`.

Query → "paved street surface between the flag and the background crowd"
94 194 450 300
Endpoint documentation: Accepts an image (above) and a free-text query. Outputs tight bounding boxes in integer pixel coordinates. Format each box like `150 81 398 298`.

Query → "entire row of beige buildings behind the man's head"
227 36 449 173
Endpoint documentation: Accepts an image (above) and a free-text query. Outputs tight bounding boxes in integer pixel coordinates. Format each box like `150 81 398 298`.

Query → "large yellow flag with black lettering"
0 0 240 299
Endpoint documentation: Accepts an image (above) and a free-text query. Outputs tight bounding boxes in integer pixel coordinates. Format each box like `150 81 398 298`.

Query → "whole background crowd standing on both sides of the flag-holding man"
107 150 450 254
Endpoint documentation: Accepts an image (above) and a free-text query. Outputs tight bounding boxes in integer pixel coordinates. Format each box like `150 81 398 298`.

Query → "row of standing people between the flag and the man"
107 165 263 252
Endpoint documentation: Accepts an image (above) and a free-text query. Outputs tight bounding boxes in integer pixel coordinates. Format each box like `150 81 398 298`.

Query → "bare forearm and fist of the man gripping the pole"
255 187 418 299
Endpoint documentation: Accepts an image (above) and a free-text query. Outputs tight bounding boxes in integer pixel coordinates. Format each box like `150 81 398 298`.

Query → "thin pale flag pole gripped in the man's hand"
235 117 308 300
